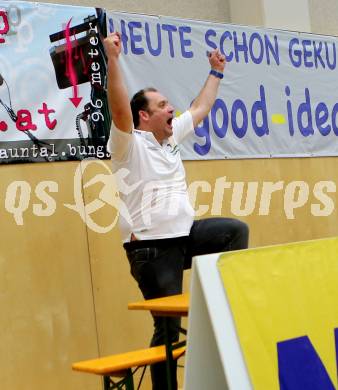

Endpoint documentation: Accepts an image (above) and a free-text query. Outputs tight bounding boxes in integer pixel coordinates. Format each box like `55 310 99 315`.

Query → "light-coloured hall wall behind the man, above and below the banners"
0 0 338 390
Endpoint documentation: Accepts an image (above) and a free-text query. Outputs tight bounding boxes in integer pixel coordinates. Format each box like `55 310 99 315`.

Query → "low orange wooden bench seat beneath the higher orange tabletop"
72 345 185 390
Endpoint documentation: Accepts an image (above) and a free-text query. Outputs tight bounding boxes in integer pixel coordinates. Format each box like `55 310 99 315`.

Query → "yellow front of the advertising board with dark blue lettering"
218 238 338 390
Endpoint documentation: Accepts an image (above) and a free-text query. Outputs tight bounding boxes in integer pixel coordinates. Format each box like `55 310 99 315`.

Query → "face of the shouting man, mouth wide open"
146 92 174 142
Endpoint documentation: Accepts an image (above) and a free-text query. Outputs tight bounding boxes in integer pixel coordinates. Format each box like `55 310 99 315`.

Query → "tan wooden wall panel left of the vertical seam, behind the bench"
0 162 100 390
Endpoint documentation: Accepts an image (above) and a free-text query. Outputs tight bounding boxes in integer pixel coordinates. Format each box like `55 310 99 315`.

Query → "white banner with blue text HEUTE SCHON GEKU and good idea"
107 12 338 160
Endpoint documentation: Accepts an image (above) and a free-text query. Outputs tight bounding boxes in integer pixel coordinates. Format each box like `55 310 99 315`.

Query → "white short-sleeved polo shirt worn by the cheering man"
107 111 194 242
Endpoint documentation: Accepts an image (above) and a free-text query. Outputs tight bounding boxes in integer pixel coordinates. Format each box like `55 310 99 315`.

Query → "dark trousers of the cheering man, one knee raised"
124 218 249 390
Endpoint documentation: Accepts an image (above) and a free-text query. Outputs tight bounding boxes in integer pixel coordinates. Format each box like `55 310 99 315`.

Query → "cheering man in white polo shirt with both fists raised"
105 33 249 390
